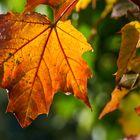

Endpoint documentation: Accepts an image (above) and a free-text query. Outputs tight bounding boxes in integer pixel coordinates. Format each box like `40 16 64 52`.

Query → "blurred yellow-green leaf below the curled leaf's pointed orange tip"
119 92 140 136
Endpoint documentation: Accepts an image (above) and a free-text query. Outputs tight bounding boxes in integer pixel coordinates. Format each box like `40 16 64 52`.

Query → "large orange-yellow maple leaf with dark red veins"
0 13 92 127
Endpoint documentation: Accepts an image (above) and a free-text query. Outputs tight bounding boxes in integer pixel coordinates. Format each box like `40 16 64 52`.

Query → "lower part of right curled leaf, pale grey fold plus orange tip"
99 73 140 119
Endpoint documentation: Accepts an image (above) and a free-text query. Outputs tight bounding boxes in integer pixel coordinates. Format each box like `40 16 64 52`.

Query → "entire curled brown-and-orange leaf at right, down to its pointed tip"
99 21 140 118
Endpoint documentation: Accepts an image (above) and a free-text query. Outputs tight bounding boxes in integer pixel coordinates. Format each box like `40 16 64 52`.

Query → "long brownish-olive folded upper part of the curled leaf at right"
116 21 140 82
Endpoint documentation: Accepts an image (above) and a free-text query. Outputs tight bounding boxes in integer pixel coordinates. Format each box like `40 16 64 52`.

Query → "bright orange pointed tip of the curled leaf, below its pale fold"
99 87 129 119
